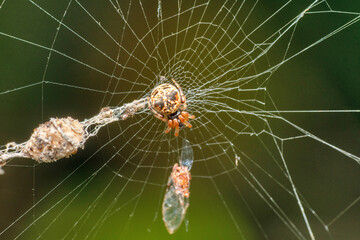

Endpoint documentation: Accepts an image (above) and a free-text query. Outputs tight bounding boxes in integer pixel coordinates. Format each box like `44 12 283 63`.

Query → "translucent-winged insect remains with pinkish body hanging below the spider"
162 139 194 234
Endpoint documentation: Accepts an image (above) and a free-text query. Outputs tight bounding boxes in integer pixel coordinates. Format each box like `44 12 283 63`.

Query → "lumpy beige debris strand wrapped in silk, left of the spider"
0 98 147 169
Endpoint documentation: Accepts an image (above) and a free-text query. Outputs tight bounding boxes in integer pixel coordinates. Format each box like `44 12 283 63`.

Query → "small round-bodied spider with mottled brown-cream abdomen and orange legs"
148 79 195 137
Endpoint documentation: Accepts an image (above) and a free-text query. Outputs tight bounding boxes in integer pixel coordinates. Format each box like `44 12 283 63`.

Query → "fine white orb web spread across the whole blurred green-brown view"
0 0 360 239
